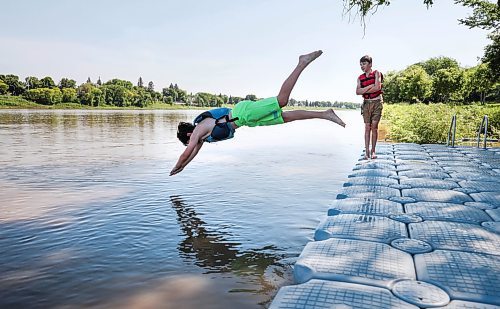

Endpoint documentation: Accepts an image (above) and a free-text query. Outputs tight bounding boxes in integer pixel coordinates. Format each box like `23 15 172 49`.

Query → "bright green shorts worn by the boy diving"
232 97 285 127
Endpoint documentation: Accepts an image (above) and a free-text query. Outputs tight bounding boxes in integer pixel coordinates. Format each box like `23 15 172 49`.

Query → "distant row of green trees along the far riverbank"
0 74 359 109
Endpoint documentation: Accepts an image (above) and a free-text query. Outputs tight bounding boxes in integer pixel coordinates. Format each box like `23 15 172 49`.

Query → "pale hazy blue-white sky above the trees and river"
0 0 489 102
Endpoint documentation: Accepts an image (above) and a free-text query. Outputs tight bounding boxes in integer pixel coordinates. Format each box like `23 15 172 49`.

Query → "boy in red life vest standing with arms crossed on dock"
356 55 384 160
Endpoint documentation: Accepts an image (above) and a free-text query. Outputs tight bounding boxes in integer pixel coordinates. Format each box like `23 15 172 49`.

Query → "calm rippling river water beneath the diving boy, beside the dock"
0 110 363 308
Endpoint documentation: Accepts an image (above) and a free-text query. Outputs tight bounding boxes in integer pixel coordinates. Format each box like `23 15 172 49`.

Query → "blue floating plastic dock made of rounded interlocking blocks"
270 144 500 309
